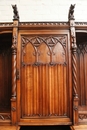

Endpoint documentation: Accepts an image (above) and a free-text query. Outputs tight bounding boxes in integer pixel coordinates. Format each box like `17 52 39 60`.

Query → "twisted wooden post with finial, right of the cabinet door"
69 5 79 125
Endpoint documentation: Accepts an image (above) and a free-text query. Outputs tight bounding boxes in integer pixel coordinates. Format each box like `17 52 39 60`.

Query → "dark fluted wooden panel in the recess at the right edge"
77 42 87 106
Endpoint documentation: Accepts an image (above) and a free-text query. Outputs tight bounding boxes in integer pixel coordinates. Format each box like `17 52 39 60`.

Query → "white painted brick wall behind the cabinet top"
0 0 87 22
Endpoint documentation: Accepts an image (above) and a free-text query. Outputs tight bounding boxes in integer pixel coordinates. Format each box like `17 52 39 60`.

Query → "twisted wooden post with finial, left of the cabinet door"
11 5 19 125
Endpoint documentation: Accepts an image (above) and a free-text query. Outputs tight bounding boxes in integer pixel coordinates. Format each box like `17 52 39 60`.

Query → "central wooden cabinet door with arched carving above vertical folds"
19 31 72 125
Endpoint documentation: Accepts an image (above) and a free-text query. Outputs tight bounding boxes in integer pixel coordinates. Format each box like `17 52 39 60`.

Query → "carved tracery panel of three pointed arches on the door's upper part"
22 35 66 64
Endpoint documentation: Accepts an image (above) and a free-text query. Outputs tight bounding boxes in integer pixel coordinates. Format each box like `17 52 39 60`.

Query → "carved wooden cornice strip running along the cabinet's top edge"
0 22 87 29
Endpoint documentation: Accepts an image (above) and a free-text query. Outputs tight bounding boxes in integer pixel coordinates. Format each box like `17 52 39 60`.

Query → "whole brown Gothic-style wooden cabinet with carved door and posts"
0 6 87 130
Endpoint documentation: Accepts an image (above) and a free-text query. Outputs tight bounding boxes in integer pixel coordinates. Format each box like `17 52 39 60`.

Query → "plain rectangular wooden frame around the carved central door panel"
17 29 72 125
